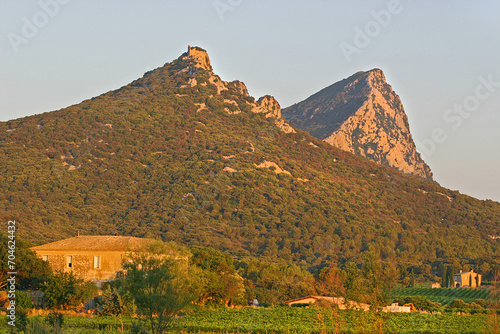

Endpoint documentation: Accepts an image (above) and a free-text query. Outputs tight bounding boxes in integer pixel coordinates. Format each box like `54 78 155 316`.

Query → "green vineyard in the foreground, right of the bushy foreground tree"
176 306 488 334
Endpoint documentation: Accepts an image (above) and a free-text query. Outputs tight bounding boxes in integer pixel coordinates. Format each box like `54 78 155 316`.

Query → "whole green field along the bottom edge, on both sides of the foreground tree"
0 306 499 334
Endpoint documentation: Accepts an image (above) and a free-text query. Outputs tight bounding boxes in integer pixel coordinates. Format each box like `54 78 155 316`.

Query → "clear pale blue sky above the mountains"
0 0 500 201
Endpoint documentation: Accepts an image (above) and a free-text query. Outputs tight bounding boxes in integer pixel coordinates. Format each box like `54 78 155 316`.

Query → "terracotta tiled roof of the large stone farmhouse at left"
31 235 152 251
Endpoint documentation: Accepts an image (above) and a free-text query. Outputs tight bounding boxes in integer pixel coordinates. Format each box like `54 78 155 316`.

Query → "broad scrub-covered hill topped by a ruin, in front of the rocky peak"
0 47 500 279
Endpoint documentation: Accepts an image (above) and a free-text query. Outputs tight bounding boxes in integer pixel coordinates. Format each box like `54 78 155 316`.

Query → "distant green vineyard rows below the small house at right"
392 288 490 306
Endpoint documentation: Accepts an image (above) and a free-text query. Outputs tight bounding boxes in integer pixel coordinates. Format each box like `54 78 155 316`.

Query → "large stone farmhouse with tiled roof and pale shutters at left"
31 235 152 287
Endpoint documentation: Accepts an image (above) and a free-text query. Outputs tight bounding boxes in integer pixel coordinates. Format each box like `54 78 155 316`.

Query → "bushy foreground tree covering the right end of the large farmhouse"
123 241 202 334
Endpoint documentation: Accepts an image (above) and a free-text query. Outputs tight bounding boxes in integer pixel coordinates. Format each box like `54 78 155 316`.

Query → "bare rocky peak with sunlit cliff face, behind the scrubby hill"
283 69 432 180
